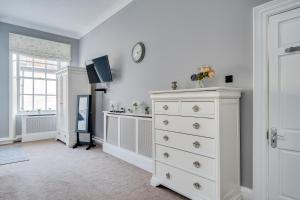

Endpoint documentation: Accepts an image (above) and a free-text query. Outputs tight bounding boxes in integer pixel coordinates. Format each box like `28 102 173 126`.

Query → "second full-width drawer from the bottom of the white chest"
155 145 216 180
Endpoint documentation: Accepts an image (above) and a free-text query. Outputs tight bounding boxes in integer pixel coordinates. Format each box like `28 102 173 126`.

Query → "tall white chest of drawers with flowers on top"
151 87 241 200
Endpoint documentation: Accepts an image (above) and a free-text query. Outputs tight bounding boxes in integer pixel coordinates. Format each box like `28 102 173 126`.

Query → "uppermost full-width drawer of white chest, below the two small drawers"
155 115 217 138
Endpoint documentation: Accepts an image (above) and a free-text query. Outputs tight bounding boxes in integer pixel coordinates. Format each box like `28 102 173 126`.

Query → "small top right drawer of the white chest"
181 101 215 116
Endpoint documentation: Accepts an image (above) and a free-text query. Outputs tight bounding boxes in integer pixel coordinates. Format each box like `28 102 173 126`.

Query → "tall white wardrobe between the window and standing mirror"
56 67 91 147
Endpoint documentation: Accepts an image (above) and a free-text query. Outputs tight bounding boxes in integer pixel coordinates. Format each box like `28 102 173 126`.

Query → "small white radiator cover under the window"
21 115 56 142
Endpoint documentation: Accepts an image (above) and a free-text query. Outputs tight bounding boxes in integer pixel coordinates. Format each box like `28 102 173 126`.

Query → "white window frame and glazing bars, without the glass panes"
11 51 69 115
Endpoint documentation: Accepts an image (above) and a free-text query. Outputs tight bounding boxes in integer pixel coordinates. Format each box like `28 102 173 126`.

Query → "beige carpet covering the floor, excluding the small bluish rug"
0 140 185 200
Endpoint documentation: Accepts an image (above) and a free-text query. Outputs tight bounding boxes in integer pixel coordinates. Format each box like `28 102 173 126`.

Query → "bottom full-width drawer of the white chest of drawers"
155 162 216 200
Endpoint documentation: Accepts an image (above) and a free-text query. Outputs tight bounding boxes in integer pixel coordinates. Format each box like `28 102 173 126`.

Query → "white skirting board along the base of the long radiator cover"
103 143 152 173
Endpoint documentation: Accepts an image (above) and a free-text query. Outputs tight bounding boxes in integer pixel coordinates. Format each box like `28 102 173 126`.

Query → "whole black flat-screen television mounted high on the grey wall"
86 55 112 84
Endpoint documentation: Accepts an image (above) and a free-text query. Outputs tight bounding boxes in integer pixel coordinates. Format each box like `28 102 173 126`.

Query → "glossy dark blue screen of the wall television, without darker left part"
93 55 112 82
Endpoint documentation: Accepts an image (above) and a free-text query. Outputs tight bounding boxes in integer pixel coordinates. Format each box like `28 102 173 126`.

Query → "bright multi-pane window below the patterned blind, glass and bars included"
12 52 69 113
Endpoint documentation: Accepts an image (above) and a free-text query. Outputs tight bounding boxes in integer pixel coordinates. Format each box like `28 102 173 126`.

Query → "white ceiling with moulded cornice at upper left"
0 0 132 39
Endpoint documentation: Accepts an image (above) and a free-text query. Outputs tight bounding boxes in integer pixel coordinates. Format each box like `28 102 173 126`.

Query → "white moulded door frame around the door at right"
253 0 300 200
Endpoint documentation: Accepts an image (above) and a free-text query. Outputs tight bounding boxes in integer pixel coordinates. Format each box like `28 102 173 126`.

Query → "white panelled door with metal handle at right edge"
269 9 300 200
